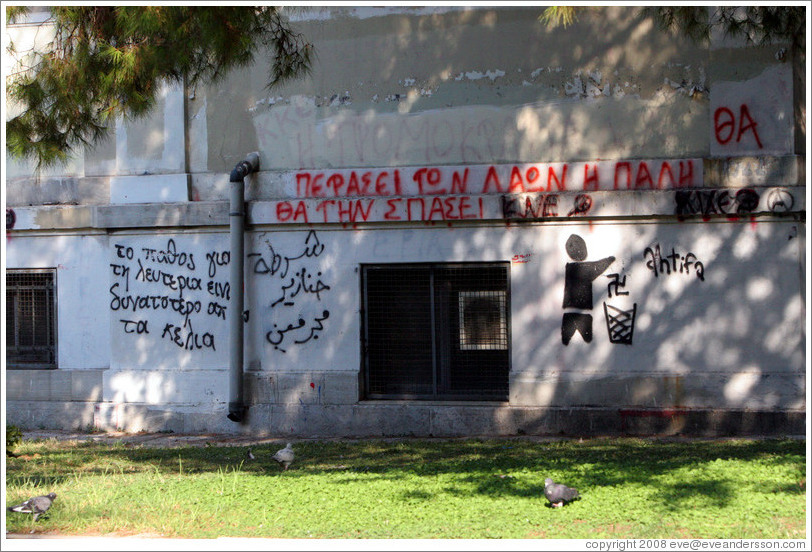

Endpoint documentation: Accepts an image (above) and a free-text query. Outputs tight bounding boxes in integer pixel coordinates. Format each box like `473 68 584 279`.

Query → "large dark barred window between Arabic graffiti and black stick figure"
362 263 510 400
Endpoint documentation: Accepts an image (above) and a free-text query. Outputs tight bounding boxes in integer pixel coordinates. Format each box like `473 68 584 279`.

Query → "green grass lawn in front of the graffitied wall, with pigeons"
6 438 806 539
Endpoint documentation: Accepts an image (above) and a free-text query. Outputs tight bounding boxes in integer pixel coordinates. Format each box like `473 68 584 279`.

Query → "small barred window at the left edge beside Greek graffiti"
6 269 56 368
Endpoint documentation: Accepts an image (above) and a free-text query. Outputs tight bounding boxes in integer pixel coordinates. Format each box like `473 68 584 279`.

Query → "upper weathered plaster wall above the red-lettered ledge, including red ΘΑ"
6 7 803 206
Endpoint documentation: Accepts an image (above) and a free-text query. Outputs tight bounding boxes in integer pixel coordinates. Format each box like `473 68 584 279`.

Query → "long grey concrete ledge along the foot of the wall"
7 401 806 438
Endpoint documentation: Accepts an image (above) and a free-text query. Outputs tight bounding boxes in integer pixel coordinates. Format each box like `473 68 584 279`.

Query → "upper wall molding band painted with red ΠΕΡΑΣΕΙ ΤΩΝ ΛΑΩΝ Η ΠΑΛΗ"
6 155 806 208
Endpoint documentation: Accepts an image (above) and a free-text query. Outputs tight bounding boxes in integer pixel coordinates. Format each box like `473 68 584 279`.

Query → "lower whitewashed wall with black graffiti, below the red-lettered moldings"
4 216 805 432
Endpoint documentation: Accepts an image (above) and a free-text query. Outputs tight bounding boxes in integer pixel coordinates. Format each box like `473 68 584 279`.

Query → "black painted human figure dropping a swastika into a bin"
561 234 615 345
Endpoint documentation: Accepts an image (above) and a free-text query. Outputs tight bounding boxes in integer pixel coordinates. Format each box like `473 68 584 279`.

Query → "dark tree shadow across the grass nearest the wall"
6 439 805 510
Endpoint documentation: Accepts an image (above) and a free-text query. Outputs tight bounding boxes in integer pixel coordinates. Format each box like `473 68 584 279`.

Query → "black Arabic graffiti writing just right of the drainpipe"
248 230 330 353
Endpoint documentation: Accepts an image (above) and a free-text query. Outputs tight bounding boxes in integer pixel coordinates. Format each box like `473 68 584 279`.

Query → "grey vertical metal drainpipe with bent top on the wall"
228 152 259 423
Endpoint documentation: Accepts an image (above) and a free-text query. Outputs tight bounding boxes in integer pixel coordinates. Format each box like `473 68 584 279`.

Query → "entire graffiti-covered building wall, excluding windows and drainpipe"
4 7 808 436
